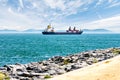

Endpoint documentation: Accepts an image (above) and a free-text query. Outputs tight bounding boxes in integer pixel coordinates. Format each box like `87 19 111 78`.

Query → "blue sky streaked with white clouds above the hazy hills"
0 0 120 33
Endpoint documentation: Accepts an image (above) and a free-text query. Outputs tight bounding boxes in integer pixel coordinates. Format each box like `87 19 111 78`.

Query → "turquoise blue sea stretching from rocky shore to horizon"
0 33 120 66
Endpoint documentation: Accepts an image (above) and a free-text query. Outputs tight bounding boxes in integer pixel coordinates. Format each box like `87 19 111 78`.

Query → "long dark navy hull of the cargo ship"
42 31 83 35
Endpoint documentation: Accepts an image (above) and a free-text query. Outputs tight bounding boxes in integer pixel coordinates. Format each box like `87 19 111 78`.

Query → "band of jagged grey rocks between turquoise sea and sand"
0 48 120 80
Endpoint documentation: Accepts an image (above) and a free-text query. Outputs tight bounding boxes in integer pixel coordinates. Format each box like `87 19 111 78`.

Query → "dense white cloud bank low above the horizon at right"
85 16 120 32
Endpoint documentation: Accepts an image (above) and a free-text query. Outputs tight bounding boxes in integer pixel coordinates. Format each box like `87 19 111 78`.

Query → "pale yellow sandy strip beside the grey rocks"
48 55 120 80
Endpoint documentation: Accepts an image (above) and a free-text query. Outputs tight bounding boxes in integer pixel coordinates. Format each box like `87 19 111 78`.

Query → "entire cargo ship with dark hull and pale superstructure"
42 25 83 35
